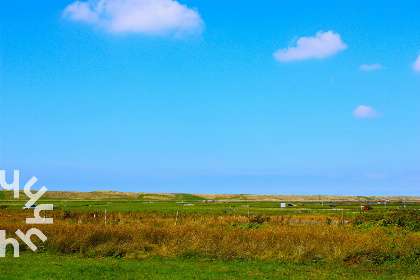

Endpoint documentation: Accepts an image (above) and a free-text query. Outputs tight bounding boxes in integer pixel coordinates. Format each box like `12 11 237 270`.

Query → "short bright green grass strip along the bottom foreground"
0 253 419 280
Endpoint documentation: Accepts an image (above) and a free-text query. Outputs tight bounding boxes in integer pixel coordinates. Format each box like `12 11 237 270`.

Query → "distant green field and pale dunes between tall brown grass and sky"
0 191 420 214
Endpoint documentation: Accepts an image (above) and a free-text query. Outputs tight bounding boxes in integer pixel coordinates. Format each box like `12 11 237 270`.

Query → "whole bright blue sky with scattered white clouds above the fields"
0 0 420 196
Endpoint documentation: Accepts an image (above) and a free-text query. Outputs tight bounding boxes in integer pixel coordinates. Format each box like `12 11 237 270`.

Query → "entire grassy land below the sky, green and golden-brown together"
0 192 420 279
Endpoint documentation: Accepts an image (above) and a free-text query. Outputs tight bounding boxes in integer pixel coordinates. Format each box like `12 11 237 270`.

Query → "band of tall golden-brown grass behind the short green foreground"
0 209 420 263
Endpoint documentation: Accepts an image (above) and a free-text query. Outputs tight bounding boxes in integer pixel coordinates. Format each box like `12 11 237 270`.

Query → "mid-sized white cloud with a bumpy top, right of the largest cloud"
274 31 347 62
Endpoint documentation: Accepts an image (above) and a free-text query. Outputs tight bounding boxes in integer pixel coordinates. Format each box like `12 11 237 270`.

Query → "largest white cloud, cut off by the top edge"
63 0 204 34
